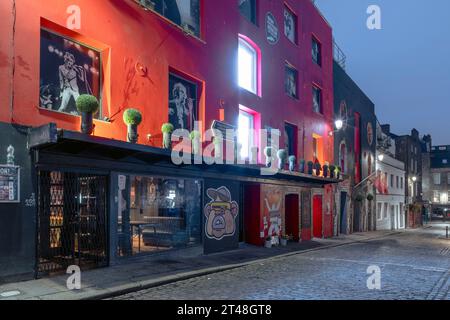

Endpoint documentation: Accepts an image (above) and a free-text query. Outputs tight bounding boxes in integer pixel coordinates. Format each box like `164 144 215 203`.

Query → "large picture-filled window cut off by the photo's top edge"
138 0 200 37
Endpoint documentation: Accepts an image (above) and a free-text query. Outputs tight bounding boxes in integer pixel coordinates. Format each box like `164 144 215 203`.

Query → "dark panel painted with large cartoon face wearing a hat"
203 180 240 254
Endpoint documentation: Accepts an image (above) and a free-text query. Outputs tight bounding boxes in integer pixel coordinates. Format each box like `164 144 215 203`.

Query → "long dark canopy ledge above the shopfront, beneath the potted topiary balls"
28 124 342 187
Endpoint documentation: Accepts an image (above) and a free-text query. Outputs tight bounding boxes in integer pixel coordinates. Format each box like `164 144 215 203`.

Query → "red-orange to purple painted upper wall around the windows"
0 0 333 162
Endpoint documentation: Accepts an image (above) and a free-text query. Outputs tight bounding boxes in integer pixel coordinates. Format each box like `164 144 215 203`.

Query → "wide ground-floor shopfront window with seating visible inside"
119 176 202 255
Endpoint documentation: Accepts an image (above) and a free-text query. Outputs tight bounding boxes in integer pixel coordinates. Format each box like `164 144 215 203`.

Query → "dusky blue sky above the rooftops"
316 0 450 145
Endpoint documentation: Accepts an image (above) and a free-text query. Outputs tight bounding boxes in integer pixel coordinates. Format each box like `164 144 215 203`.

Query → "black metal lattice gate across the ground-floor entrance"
37 171 108 276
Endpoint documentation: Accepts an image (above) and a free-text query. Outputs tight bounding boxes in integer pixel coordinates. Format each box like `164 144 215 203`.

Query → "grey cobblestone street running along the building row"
115 224 450 300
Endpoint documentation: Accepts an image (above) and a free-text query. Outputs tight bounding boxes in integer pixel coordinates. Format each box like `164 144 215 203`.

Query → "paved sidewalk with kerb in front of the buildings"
0 231 398 300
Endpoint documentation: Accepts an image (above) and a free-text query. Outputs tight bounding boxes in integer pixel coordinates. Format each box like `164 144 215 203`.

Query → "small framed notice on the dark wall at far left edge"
0 165 20 203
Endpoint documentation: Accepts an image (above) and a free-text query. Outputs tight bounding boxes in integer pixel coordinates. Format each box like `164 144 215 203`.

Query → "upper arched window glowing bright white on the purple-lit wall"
238 39 258 94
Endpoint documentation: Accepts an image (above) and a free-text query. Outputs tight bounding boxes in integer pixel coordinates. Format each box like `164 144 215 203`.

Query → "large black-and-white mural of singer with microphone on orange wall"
39 29 101 117
